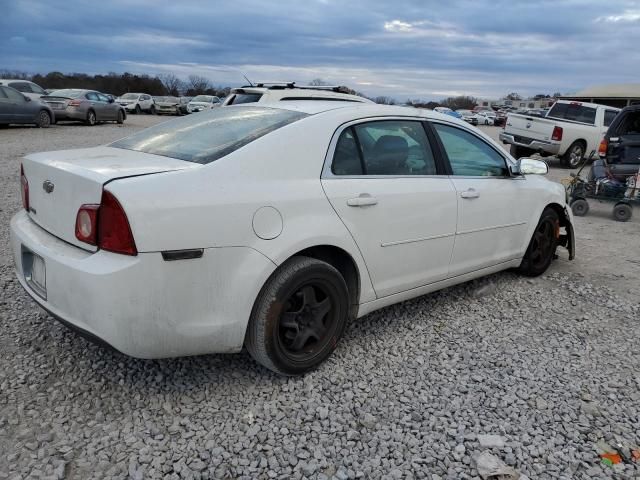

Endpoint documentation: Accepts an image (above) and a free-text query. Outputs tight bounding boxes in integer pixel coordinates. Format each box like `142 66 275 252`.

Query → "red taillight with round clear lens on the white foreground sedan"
76 190 138 255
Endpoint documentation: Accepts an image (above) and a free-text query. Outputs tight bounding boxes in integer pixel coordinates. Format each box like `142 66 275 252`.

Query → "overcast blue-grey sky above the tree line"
0 0 640 99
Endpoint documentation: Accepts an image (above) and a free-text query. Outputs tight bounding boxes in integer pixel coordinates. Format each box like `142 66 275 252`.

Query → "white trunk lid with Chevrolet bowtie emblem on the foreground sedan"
22 147 200 251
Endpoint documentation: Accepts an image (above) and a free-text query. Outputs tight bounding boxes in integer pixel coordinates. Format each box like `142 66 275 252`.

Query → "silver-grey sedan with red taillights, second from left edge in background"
40 88 127 125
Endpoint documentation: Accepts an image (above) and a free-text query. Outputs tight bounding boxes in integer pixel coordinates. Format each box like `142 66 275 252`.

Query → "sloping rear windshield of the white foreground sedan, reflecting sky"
110 107 308 164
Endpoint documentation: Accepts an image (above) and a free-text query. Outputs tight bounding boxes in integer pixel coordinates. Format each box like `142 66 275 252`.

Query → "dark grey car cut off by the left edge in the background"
0 86 55 128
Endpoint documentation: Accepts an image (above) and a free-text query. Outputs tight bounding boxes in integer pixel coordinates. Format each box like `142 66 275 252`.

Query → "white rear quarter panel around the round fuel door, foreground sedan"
106 112 375 301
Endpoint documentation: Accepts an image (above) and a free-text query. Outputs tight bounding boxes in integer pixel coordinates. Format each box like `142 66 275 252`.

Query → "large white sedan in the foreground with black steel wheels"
11 101 574 375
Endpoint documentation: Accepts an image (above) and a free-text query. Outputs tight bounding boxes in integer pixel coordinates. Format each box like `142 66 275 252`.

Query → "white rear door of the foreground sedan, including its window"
322 119 457 297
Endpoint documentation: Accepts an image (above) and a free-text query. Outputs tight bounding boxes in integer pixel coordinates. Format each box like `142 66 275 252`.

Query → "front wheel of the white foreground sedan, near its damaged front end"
518 208 560 277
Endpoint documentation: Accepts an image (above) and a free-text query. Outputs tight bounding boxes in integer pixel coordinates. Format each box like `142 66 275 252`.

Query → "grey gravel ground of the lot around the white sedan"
0 116 640 480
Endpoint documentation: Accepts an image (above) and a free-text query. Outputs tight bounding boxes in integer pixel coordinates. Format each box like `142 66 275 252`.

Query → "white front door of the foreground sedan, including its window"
432 122 536 277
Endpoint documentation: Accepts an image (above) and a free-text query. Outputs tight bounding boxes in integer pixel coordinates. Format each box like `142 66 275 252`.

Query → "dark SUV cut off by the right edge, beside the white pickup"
598 105 640 179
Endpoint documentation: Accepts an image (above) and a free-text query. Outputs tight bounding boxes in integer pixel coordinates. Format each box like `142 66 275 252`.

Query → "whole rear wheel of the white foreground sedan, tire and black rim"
245 256 349 375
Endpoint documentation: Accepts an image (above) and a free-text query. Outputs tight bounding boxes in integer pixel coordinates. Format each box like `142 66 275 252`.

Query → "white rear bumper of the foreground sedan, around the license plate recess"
11 211 275 358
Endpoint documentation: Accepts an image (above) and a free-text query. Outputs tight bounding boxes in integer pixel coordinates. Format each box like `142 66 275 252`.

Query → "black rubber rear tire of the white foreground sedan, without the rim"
245 257 349 375
